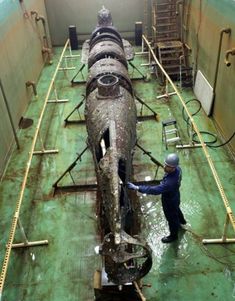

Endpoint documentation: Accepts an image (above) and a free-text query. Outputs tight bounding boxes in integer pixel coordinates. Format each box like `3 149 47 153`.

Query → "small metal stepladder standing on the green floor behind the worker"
162 119 181 149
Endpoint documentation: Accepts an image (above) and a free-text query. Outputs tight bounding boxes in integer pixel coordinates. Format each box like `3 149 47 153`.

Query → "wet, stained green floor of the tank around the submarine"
0 45 235 301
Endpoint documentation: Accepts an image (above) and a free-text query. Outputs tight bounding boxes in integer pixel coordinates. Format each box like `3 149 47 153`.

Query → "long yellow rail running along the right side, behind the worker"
142 35 235 231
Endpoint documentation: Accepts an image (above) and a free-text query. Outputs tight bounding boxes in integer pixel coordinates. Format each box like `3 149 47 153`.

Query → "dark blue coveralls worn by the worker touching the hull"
139 166 186 237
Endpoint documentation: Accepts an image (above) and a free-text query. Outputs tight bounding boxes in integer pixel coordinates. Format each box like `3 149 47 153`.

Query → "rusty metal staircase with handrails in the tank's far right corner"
152 0 192 87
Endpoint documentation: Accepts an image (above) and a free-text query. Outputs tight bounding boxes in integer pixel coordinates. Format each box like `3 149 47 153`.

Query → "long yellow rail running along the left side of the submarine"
0 40 69 300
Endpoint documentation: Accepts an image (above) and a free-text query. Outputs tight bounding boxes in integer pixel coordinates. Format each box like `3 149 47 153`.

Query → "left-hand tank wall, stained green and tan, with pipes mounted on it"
0 0 51 177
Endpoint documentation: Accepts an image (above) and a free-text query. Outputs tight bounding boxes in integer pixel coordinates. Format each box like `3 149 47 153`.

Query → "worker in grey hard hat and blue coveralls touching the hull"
127 153 186 243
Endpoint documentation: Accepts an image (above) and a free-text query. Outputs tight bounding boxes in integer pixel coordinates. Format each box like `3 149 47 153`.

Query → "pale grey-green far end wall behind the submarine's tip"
45 0 144 45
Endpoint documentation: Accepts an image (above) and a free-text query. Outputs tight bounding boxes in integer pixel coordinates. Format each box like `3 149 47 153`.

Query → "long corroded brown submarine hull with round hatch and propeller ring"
85 6 152 284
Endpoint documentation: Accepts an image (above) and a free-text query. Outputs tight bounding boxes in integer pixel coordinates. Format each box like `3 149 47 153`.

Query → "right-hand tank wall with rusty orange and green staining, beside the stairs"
185 0 235 152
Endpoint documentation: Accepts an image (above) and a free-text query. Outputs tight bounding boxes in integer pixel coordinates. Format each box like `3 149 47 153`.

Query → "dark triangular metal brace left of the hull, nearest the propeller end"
52 146 97 196
